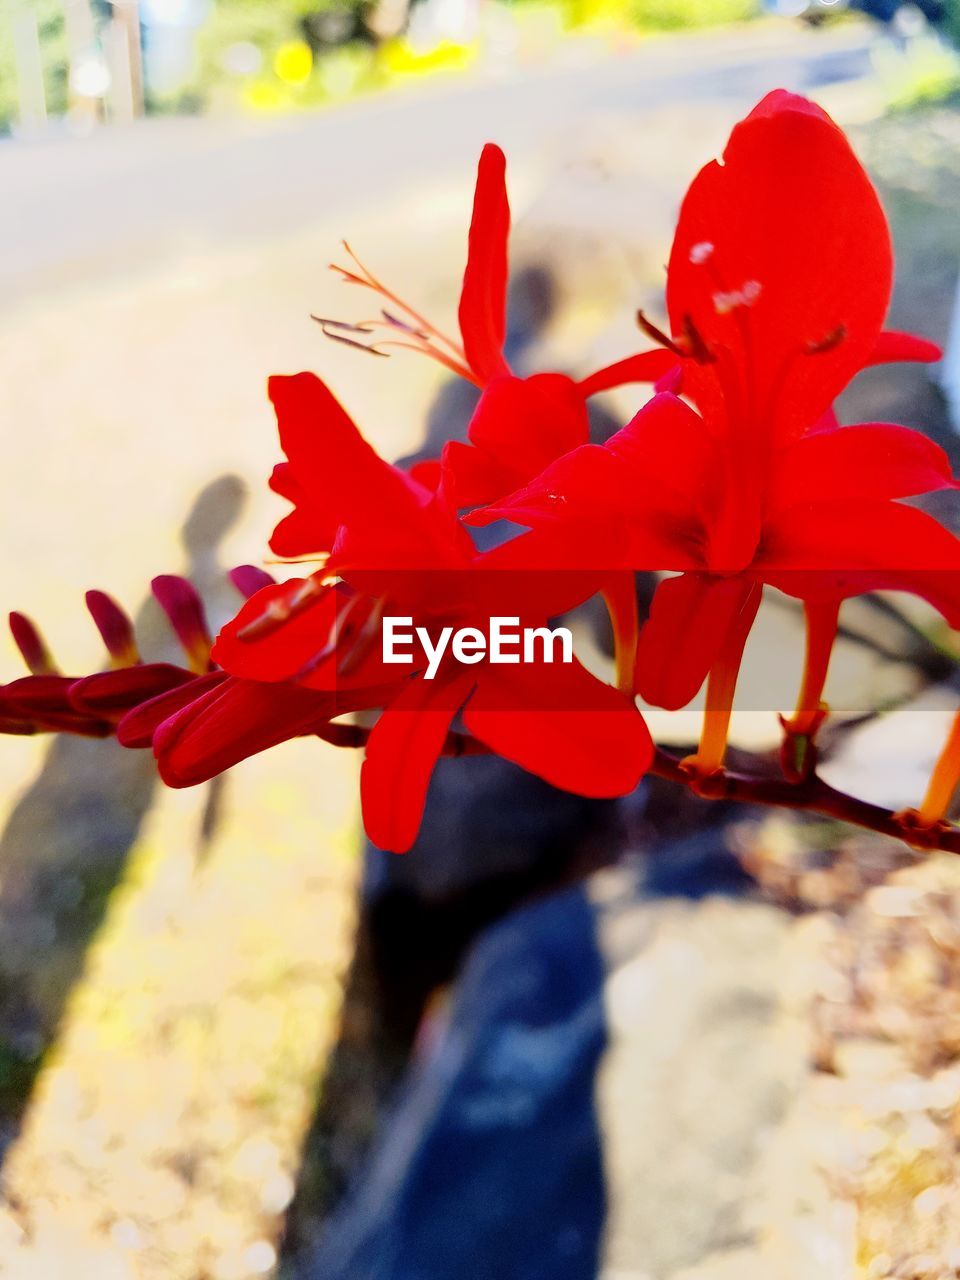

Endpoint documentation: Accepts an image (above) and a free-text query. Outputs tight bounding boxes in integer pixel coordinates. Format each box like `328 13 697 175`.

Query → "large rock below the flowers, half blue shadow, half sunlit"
300 868 804 1280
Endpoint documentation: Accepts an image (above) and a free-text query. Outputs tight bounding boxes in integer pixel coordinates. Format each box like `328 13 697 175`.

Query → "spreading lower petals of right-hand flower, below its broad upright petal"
468 393 960 762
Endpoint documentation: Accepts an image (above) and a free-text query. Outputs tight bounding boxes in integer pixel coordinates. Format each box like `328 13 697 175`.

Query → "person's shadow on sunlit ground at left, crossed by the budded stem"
0 476 244 1147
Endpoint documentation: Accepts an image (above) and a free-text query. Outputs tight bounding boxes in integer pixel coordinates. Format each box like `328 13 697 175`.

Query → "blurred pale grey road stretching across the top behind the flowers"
0 26 876 307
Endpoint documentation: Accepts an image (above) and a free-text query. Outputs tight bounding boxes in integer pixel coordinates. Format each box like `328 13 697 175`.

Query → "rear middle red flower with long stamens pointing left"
320 143 676 507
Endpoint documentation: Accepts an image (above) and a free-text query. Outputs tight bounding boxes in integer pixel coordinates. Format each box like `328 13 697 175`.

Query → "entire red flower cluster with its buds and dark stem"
0 91 960 851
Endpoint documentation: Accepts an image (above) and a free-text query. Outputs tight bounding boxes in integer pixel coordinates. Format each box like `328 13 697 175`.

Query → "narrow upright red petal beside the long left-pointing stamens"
460 142 509 383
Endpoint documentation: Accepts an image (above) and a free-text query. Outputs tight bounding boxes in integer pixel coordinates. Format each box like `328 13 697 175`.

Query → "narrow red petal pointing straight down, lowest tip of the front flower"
360 673 474 854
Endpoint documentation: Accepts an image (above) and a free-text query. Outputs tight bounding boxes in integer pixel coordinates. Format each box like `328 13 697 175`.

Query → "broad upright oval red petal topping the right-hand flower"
667 91 892 436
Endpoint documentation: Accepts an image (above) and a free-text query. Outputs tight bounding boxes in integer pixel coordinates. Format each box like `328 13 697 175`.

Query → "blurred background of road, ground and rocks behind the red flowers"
0 0 960 1280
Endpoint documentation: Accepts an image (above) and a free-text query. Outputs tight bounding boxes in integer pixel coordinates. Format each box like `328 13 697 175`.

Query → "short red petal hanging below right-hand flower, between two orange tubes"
636 573 754 710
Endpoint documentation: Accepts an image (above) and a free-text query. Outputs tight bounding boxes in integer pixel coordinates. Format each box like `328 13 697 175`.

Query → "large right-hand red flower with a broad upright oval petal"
470 91 960 763
